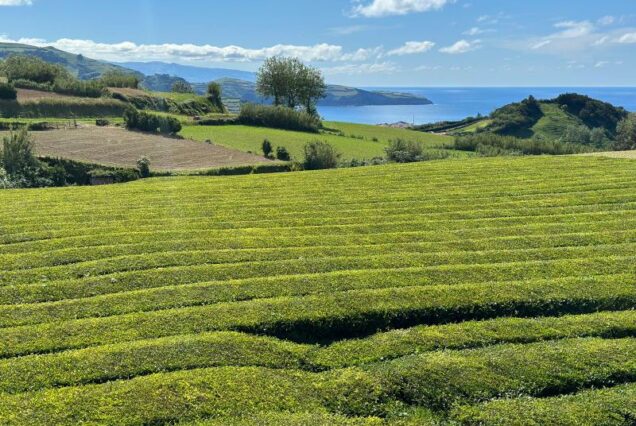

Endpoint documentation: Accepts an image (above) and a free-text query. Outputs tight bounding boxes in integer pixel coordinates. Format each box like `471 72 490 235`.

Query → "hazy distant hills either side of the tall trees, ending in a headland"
0 43 432 106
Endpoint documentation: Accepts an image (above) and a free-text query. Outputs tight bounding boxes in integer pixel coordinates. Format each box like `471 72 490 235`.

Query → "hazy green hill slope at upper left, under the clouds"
0 43 138 80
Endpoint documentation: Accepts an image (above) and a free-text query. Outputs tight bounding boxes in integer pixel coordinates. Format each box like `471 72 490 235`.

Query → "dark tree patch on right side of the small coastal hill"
550 93 628 135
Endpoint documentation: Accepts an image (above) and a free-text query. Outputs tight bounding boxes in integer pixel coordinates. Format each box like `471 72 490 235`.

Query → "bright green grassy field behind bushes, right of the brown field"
181 122 452 160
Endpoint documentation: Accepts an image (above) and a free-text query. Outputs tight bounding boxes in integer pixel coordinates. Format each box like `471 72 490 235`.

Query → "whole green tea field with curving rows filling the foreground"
0 157 636 425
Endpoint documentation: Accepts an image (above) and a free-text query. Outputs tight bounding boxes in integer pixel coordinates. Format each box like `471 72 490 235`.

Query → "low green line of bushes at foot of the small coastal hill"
453 133 590 157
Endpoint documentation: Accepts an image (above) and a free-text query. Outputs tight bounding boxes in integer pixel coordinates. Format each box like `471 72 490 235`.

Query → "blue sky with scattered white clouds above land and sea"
0 0 636 87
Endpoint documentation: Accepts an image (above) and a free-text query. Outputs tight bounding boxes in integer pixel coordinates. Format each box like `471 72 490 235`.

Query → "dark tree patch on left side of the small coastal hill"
490 96 543 135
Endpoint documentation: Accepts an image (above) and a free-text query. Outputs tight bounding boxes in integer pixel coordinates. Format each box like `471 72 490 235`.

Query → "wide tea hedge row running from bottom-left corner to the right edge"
0 339 636 425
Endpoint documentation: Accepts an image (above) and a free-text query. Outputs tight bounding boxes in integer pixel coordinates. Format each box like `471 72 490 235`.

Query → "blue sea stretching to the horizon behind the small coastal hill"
318 87 636 124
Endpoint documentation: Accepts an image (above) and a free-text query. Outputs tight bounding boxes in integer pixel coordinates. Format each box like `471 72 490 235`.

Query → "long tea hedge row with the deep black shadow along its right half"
0 277 636 357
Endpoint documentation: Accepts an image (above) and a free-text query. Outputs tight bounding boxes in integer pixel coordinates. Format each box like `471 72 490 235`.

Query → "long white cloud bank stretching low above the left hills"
0 36 382 63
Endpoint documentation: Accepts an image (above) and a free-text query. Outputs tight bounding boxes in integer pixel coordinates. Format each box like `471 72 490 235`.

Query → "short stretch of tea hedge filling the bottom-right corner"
452 382 636 426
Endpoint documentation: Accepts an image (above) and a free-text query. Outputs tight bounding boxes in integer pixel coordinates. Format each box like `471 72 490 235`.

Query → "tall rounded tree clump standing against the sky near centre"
256 57 327 115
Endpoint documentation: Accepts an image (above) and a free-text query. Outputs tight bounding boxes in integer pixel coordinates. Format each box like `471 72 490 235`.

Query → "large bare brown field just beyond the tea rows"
0 126 270 171
